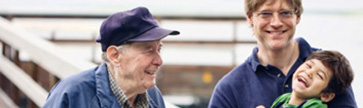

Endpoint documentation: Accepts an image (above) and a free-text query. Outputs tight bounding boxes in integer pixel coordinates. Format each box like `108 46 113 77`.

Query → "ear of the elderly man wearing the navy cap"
106 45 121 66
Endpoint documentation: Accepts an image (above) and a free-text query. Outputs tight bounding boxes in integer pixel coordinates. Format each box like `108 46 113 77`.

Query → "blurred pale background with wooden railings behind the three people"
0 0 363 108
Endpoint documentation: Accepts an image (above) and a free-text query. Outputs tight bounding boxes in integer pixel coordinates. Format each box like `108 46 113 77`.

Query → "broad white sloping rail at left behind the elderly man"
0 18 95 78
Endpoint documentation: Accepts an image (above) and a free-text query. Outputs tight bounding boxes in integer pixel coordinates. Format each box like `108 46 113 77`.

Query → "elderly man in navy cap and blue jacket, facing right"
44 7 179 108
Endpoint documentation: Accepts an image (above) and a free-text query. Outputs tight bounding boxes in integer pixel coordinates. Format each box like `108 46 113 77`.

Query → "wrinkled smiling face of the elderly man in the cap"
118 41 163 92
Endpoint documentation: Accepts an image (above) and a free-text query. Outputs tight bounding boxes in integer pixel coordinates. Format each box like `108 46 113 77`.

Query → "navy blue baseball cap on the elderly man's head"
96 7 180 51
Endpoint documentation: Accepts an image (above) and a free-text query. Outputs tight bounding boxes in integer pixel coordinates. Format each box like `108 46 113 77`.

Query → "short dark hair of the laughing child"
306 51 354 93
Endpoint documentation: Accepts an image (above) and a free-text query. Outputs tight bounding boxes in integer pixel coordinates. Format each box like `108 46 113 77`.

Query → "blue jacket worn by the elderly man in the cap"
44 63 165 108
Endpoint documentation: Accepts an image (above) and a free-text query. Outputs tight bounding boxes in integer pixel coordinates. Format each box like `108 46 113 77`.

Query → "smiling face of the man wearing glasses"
248 0 300 50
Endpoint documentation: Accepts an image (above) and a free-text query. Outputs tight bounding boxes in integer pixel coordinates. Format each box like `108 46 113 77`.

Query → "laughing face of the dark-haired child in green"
292 59 332 99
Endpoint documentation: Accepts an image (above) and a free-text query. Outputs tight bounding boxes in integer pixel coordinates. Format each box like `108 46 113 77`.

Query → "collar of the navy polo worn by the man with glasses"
247 37 320 72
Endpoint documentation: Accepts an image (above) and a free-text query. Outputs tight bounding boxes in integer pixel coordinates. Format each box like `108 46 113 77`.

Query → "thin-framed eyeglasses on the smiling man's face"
255 10 295 21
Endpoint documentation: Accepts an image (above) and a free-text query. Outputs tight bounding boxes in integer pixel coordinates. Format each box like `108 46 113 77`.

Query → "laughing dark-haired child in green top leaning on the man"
271 51 353 108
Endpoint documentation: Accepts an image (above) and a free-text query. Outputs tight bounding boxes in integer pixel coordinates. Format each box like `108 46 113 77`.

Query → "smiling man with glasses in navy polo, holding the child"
209 0 357 108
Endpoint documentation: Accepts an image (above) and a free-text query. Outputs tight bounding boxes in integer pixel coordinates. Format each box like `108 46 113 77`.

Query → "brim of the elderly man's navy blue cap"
127 27 180 42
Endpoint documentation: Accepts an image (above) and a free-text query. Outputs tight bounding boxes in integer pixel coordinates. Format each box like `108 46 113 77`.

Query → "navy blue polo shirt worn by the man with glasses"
209 38 357 108
